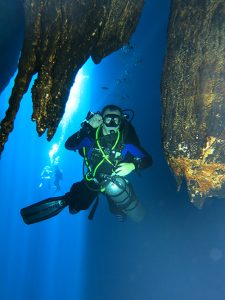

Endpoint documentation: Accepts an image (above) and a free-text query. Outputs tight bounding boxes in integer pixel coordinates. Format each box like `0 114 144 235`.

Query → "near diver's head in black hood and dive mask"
101 105 122 135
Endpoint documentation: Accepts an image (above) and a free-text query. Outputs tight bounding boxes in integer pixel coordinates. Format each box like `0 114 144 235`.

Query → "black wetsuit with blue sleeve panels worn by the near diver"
65 121 152 213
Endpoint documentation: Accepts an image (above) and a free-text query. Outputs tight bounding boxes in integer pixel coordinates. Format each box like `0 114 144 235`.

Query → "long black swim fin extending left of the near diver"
20 196 68 224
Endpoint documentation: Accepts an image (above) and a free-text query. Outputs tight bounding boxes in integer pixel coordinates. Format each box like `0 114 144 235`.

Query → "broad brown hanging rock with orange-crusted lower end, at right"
161 0 225 208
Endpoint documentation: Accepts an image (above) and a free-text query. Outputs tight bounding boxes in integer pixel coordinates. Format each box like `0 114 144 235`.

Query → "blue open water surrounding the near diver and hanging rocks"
0 0 225 300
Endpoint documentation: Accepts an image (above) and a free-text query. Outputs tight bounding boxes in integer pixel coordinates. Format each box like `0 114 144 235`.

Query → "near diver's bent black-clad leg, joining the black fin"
66 180 98 214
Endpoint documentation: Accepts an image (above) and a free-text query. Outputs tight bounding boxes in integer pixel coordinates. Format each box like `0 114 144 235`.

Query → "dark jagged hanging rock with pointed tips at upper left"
0 0 144 153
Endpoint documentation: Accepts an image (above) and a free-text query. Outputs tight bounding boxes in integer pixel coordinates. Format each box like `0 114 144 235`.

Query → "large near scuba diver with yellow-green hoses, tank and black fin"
21 105 152 224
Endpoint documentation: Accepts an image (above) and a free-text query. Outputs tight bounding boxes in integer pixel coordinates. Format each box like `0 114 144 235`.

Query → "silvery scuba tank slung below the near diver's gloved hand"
101 175 145 222
